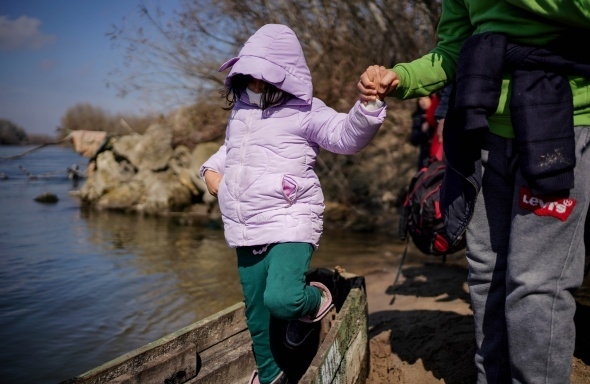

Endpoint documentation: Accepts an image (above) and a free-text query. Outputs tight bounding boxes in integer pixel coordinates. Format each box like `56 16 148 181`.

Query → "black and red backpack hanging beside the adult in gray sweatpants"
399 157 465 260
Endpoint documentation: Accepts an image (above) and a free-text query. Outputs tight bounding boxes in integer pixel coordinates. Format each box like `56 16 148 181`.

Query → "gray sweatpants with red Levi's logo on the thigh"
467 127 590 384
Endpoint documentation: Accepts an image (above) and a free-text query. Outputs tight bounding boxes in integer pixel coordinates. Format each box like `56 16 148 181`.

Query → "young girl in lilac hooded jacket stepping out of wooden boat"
200 24 385 384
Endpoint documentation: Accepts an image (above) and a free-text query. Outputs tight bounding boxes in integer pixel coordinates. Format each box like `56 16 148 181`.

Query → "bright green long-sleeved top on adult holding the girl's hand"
392 0 590 138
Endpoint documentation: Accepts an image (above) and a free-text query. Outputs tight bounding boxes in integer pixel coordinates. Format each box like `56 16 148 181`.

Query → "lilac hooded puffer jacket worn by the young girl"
200 24 385 248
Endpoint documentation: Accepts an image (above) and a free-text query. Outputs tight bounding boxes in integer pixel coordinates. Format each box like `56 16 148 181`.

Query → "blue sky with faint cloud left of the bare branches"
0 0 182 136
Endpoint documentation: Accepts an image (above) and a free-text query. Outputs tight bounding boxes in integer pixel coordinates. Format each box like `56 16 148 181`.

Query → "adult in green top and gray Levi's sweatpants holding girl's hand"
358 0 590 384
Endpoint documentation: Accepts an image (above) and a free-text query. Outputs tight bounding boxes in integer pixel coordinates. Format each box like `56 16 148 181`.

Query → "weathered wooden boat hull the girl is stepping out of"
62 268 369 384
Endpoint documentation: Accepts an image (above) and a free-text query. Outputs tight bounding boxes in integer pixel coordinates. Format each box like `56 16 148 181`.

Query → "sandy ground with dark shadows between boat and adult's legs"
364 250 590 384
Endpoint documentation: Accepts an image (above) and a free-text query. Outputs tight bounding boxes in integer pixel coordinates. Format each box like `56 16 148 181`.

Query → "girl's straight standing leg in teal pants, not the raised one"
236 247 281 383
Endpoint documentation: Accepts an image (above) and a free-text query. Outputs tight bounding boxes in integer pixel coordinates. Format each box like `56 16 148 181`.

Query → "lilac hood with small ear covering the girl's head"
219 24 313 104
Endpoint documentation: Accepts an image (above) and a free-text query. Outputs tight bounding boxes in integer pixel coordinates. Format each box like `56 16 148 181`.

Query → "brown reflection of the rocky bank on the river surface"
84 207 241 319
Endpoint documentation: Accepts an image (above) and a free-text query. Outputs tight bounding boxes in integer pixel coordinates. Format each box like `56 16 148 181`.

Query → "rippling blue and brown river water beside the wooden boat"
0 146 402 384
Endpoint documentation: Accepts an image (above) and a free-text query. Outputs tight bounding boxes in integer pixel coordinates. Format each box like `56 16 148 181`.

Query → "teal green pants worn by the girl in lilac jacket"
236 243 321 384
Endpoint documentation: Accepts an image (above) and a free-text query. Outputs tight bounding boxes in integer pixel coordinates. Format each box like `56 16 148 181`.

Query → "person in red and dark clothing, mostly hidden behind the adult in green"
410 94 438 169
